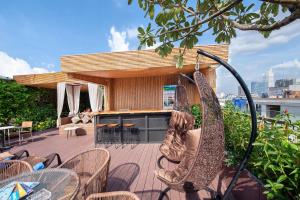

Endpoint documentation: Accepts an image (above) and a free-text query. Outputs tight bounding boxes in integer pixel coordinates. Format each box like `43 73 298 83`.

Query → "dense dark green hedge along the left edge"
0 80 56 130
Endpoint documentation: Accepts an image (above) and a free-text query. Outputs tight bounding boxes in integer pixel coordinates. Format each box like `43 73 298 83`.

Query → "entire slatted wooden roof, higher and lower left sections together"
14 45 228 88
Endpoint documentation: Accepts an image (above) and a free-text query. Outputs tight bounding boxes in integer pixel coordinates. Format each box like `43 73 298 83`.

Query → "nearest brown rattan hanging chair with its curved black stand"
155 50 257 200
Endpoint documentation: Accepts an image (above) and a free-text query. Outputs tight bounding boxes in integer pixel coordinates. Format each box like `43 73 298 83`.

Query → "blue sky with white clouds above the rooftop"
0 0 300 93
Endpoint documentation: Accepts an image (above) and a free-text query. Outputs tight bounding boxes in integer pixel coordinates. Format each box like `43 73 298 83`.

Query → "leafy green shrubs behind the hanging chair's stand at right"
223 104 300 200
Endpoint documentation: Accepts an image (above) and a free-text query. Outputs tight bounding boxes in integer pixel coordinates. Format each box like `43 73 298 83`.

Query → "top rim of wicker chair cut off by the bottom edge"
86 191 139 200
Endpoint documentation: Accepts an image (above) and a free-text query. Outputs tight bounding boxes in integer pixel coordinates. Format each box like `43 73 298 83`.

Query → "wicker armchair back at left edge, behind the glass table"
0 160 33 181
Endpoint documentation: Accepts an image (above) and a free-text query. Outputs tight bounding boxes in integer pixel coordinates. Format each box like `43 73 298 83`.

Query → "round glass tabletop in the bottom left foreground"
0 169 79 199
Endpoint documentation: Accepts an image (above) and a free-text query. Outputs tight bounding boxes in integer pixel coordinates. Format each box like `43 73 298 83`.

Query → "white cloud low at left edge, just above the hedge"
0 51 49 78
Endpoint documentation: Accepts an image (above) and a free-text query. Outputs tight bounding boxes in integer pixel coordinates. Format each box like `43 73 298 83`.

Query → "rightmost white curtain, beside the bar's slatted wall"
88 83 104 112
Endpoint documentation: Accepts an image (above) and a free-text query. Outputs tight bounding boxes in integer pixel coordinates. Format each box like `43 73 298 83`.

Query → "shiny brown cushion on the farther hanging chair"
159 111 195 162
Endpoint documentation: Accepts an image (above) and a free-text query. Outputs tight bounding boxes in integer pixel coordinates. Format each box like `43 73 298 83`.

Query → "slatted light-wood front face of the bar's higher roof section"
61 45 228 76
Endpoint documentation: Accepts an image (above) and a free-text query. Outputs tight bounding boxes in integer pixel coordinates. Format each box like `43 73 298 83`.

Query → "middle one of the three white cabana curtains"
66 84 80 116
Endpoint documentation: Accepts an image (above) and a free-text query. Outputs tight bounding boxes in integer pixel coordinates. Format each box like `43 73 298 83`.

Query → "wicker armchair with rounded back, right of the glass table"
59 148 110 199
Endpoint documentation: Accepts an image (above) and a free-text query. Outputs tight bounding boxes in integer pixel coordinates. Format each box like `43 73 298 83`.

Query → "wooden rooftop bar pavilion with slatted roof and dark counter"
14 45 228 143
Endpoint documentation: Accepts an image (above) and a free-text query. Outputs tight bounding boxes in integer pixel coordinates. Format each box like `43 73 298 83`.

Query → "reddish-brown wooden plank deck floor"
12 129 264 200
